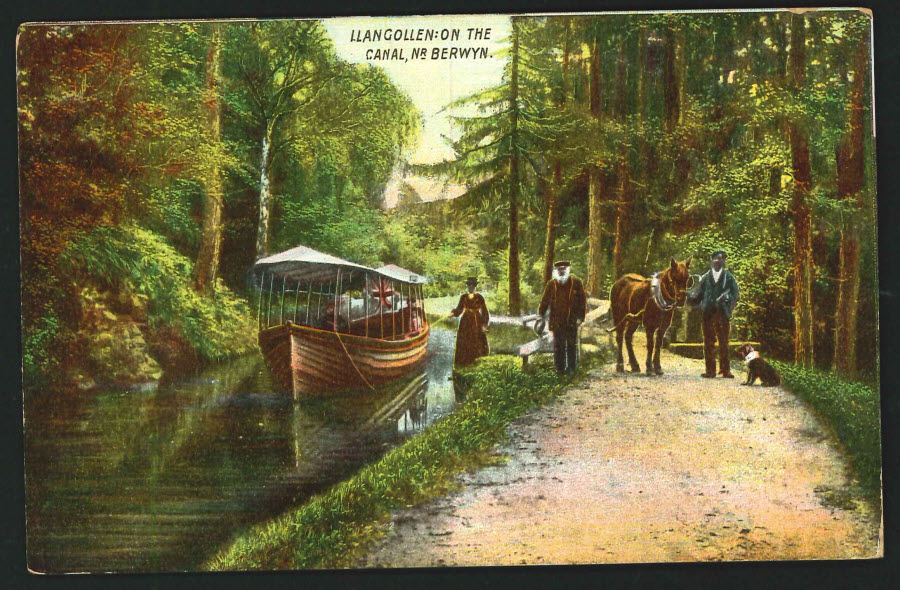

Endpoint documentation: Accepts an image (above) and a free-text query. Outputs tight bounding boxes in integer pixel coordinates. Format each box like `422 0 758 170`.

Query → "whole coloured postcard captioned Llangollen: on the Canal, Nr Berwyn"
16 8 884 574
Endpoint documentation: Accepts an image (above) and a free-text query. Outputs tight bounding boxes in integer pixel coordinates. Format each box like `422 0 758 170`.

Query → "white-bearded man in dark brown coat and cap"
538 260 587 373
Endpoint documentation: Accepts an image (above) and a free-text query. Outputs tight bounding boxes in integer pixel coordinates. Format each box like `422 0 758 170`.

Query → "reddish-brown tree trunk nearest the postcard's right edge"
834 28 869 378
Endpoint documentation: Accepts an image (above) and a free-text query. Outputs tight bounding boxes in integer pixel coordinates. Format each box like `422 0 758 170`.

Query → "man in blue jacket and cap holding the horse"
687 250 740 379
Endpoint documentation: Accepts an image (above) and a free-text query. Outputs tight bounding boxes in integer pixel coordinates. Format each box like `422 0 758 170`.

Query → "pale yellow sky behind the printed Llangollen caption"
322 15 509 164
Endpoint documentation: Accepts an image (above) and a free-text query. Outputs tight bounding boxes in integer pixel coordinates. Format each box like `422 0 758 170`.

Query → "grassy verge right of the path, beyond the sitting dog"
772 362 881 497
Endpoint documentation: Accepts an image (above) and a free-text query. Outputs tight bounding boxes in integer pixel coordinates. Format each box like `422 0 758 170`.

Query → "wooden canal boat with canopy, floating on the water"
254 246 430 399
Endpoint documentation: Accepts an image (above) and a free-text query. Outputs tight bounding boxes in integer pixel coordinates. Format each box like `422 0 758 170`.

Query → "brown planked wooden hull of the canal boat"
259 322 430 398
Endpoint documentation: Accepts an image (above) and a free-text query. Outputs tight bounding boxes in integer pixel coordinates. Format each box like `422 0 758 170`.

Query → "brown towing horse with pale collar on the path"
609 257 692 375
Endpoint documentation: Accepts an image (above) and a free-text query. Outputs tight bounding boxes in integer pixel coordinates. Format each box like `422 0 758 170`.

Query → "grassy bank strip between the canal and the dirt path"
204 356 599 570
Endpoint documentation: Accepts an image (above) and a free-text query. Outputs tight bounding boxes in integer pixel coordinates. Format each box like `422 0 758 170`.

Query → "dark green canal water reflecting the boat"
25 328 456 573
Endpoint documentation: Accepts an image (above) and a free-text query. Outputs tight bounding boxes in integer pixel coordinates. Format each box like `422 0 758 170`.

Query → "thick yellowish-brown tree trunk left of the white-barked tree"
195 24 225 295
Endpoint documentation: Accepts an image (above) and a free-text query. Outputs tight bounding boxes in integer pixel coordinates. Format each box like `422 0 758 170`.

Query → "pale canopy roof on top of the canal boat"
253 246 427 284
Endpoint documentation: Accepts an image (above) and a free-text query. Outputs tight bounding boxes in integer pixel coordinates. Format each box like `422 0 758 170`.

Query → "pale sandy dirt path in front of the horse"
358 339 881 567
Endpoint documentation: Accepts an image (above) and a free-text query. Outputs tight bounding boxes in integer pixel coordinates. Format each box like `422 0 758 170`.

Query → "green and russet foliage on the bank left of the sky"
18 21 419 382
